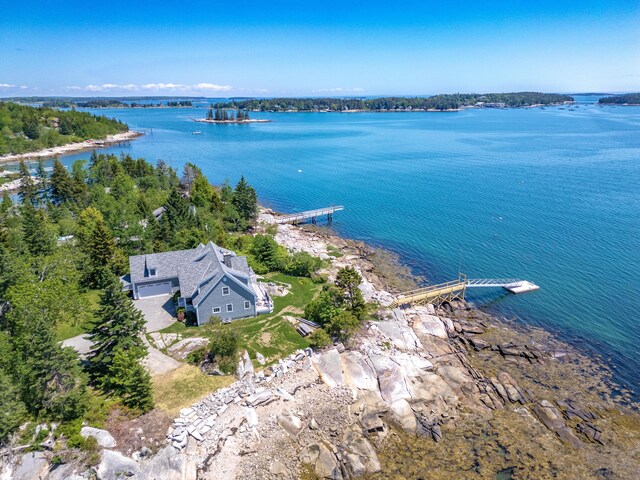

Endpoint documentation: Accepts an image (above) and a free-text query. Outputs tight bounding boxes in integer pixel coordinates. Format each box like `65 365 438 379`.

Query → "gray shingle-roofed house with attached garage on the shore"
128 242 273 325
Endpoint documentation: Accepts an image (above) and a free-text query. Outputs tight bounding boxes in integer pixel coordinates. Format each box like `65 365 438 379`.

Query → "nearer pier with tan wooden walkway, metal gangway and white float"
390 273 540 308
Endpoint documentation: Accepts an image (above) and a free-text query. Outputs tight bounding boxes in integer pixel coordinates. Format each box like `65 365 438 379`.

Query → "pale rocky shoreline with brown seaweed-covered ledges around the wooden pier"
3 211 640 480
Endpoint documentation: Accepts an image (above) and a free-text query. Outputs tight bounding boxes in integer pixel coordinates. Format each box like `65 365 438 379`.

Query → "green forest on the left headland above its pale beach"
0 102 129 155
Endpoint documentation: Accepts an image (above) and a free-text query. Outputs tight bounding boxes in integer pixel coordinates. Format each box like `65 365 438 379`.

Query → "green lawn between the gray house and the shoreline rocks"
161 273 321 362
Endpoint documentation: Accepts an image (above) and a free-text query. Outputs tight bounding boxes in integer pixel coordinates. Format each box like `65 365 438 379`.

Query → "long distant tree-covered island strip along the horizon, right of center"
219 92 573 112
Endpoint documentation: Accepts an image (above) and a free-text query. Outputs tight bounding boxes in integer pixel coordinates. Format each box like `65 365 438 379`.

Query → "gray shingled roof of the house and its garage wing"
129 242 255 304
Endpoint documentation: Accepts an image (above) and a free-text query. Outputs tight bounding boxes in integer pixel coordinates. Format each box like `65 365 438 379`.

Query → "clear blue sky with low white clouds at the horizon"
0 0 640 97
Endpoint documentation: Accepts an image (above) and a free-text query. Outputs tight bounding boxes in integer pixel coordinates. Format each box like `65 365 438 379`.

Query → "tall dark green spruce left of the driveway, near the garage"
88 276 147 384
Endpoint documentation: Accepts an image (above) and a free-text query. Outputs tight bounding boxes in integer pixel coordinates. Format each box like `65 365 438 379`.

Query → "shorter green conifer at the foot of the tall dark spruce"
109 350 153 413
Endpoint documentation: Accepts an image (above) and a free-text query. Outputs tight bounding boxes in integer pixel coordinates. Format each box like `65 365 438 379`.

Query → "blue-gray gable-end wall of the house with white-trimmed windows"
196 275 256 325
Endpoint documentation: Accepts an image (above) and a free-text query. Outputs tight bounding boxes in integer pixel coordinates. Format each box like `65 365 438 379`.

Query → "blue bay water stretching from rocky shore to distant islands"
33 98 640 395
